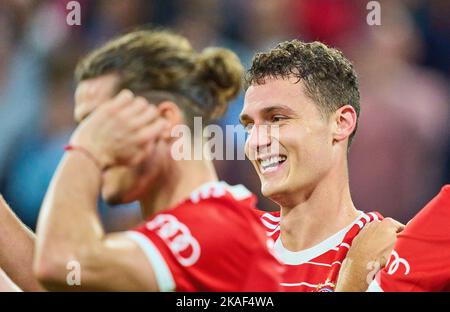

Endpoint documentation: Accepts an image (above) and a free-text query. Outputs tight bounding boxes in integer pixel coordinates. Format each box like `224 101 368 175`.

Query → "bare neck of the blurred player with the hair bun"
140 160 218 218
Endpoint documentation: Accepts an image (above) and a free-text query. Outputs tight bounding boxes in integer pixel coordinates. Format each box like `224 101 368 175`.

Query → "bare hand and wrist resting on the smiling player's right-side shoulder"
336 218 404 292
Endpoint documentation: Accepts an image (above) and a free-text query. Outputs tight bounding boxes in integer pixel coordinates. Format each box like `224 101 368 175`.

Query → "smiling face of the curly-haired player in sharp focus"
241 78 334 202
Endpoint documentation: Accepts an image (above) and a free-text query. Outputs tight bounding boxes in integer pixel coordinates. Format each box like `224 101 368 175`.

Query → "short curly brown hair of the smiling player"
246 40 360 146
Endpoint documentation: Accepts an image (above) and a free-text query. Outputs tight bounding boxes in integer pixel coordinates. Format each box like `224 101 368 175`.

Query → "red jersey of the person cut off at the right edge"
369 185 450 291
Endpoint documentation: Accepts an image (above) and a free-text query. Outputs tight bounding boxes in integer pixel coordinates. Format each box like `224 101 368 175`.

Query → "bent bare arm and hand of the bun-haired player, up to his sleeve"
35 90 167 291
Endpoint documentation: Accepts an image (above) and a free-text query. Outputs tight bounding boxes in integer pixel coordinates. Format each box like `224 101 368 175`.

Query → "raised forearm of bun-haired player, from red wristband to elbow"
35 152 104 283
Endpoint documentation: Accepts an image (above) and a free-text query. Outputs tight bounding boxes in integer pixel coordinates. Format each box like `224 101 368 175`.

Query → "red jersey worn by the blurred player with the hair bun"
127 182 283 292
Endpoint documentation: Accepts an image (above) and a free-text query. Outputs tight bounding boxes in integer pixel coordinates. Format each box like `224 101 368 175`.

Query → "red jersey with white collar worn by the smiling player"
261 208 383 292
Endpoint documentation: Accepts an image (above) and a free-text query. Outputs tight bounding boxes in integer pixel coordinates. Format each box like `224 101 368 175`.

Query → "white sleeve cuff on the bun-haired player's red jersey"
125 231 175 292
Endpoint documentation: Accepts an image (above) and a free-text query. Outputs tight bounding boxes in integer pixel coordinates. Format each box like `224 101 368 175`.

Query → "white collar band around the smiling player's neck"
274 211 364 265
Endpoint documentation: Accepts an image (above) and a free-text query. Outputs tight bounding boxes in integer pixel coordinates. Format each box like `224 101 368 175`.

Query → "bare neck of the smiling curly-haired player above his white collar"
280 161 358 251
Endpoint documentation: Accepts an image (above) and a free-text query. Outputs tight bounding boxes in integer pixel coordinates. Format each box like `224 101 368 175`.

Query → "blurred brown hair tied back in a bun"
75 29 244 125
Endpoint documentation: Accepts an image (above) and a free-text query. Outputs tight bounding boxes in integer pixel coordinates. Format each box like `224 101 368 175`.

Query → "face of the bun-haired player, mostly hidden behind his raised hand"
74 74 168 204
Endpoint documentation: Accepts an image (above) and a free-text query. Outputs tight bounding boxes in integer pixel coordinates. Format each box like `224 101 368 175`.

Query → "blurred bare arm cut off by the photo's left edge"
0 195 43 291
